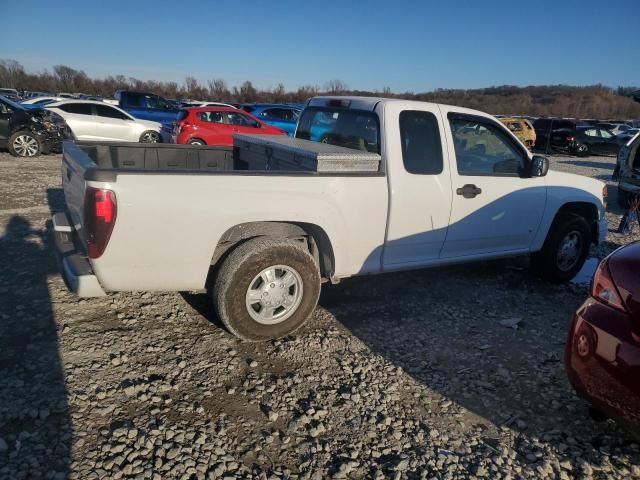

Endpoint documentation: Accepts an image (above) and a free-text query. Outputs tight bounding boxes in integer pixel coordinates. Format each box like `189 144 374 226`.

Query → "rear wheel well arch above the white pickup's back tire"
211 222 335 279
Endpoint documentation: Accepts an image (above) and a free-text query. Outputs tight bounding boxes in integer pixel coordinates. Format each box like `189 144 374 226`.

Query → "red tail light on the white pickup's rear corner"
84 187 117 258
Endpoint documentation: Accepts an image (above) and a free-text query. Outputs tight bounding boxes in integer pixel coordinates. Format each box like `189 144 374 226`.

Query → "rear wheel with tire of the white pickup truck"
212 237 320 341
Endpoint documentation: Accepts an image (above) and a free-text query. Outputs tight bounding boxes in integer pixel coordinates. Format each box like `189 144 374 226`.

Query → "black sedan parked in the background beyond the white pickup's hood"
550 125 620 156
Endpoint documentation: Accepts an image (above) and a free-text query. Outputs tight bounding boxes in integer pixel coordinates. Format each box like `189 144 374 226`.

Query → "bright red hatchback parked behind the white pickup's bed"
173 107 287 146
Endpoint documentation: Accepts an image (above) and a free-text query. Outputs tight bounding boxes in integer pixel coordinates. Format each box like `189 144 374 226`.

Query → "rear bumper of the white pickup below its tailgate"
53 213 106 298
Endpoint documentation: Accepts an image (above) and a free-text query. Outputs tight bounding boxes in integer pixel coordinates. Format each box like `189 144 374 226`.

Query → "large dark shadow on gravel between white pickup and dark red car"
319 259 640 468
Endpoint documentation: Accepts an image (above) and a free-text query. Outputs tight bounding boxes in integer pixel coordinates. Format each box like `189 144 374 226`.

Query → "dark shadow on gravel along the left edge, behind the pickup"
0 216 72 480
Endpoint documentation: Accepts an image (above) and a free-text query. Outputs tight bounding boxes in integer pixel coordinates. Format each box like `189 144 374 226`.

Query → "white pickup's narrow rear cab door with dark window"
383 102 451 270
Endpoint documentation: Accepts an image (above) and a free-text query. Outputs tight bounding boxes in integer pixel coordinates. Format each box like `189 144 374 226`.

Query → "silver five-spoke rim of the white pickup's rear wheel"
245 265 302 325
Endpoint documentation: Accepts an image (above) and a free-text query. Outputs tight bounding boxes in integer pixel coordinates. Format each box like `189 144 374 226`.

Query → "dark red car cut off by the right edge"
565 242 640 434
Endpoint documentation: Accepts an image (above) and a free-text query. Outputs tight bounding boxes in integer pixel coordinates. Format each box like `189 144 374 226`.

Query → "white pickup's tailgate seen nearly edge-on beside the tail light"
62 141 96 246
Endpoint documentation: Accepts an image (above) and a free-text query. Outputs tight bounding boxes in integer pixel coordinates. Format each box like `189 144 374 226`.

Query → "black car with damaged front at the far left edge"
0 96 66 157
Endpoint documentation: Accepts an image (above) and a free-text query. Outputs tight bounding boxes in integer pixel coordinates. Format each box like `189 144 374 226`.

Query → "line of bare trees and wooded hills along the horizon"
0 59 640 119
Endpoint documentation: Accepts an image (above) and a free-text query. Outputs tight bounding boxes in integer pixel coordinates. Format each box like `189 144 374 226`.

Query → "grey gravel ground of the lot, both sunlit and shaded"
0 153 640 480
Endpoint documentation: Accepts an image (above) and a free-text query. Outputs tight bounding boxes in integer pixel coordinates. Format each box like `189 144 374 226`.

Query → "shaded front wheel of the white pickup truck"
531 216 591 283
